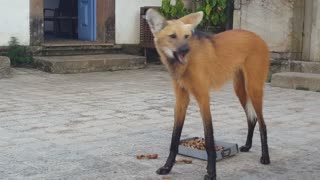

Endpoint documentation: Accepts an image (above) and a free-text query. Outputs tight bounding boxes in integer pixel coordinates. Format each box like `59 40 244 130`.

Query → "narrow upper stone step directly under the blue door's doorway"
33 44 122 56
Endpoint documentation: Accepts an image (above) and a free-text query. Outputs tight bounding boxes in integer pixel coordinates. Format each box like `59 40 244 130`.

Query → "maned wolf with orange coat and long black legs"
146 9 270 179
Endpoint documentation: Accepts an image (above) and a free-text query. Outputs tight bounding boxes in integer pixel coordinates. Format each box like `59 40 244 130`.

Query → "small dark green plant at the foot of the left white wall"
6 37 33 66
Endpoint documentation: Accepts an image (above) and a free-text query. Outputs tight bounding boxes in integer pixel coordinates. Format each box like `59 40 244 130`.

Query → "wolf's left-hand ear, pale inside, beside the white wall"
146 9 167 34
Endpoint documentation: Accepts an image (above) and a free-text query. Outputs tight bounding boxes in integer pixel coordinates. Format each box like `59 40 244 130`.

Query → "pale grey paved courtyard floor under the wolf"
0 66 320 180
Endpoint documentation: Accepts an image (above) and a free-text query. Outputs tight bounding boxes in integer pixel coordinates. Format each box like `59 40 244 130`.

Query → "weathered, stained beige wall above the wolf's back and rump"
234 0 304 59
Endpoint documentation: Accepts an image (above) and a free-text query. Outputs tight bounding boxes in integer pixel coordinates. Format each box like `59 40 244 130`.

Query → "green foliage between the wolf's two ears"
160 0 191 19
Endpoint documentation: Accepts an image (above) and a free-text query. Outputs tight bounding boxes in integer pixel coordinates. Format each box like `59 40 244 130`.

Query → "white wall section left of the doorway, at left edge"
0 0 30 46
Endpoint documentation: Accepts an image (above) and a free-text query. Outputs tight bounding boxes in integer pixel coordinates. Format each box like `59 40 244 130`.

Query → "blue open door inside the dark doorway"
78 0 96 41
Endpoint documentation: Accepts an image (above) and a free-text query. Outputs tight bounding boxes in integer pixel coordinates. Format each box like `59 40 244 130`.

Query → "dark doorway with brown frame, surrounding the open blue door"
29 0 115 46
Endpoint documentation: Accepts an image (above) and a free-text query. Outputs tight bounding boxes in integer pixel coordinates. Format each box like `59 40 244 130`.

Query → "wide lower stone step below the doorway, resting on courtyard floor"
34 54 145 74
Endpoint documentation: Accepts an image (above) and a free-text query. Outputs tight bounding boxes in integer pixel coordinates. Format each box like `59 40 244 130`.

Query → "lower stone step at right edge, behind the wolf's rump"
271 72 320 92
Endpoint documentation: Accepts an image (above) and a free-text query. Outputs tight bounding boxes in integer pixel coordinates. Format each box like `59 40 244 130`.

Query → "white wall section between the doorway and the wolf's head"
116 0 162 44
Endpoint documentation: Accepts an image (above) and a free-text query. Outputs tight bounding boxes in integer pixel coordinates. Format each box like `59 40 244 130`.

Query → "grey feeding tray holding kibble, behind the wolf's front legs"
178 137 239 161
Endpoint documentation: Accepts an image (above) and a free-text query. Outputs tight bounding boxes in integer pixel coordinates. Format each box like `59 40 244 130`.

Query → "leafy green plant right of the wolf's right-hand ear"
194 0 228 29
